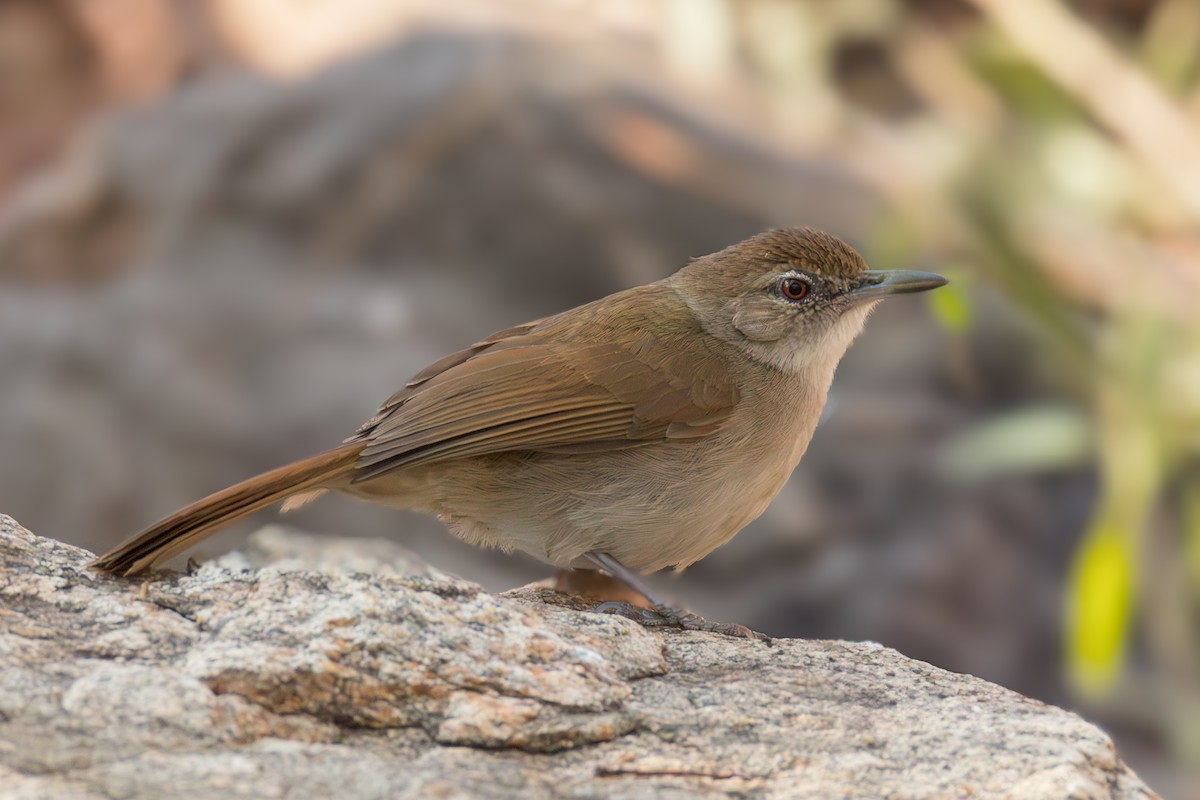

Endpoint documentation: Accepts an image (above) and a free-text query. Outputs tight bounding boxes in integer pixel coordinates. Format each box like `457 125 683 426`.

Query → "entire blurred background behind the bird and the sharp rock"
0 0 1200 798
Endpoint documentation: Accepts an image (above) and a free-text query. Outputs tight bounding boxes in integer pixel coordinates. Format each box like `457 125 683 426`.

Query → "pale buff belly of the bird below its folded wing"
353 441 794 572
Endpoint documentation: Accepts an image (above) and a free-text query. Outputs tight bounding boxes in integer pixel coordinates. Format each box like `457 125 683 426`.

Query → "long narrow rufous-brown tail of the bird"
91 444 362 575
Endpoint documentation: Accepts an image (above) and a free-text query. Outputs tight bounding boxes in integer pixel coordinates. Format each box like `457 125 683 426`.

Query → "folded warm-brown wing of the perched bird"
350 323 737 482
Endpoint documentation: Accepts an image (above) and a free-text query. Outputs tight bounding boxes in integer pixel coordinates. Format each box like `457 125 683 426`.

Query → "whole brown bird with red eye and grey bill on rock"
92 228 946 636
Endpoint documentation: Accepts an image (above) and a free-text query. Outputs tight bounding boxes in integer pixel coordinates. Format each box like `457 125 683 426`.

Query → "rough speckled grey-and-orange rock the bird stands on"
0 516 1153 800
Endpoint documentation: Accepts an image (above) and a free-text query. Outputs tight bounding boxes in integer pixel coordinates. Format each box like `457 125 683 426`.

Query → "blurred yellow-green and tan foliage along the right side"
696 0 1200 777
